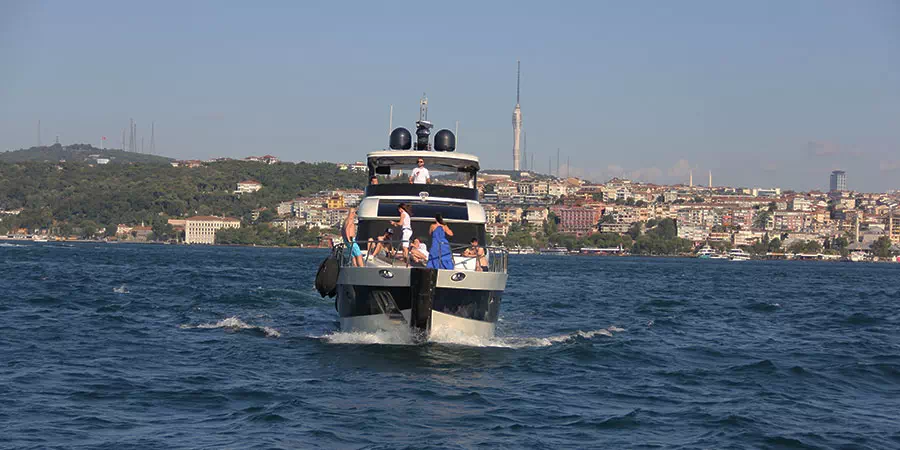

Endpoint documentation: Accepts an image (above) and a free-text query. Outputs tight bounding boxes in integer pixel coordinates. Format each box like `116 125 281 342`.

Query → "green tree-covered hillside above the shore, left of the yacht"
0 161 366 231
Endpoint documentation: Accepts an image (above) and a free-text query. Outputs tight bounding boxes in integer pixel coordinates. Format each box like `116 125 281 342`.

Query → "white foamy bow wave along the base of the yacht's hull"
310 326 625 349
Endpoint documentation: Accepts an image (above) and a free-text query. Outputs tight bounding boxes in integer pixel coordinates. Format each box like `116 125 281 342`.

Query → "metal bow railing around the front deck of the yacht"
331 240 509 273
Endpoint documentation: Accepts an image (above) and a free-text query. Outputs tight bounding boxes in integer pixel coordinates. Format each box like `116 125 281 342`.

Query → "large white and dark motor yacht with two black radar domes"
316 97 509 340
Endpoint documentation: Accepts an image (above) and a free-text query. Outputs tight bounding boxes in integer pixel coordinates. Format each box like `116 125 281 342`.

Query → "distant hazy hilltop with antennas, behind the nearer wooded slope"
0 144 172 164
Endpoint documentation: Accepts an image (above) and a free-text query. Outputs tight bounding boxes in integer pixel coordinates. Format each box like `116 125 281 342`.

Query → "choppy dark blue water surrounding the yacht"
0 243 900 449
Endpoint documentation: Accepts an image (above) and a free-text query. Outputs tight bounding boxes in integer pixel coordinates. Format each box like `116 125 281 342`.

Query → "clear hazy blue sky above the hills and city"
0 0 900 192
